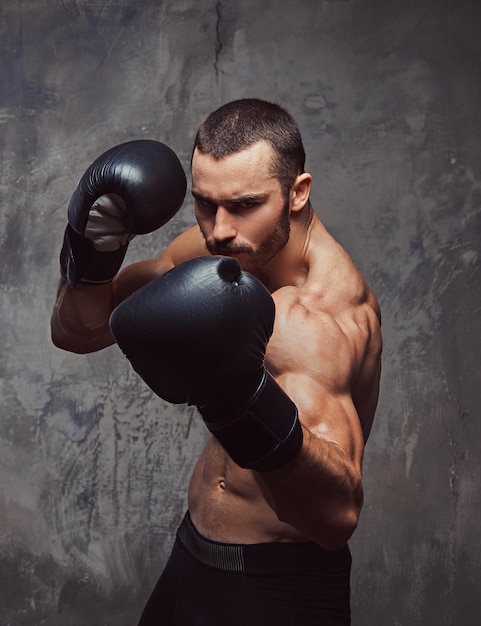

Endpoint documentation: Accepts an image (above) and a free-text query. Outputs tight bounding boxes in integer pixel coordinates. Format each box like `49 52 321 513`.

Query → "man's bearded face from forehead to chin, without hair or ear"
192 142 290 274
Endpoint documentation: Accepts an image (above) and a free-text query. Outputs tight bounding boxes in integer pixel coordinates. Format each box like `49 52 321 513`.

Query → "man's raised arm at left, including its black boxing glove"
51 140 187 353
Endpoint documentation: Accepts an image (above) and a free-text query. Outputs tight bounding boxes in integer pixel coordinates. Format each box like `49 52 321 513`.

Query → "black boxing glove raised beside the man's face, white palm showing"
60 139 187 287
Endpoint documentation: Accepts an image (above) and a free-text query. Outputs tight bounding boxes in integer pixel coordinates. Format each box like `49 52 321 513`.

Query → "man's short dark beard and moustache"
202 202 291 275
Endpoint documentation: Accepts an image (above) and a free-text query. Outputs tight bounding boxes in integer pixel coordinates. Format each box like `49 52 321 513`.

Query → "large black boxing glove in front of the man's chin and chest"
110 257 303 471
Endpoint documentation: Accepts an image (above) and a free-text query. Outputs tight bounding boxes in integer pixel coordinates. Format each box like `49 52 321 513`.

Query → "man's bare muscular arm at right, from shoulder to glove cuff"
254 292 381 549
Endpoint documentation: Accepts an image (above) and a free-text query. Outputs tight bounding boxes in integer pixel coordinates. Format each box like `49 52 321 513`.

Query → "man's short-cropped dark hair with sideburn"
194 98 306 195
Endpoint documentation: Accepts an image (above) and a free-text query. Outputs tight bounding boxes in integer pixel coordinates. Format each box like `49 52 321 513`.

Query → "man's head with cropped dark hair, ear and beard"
192 100 311 275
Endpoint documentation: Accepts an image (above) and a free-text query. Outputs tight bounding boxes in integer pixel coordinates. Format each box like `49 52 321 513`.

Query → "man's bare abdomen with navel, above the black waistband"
188 437 308 543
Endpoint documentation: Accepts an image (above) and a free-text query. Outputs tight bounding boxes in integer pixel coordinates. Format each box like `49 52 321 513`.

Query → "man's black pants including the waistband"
139 514 351 626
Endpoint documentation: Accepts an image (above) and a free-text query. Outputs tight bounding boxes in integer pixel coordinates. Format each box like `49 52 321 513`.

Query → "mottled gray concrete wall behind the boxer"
0 0 481 626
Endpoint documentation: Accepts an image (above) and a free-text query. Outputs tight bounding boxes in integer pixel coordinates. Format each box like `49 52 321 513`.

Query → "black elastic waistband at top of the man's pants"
177 512 351 574
